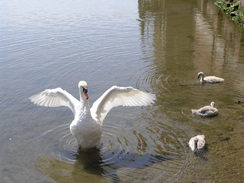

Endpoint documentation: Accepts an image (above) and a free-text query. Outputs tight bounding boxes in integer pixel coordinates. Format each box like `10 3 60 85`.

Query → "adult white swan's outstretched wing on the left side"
29 88 80 114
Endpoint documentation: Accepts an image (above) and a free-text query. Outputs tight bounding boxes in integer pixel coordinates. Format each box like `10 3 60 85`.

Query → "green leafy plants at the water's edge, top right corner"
215 0 244 28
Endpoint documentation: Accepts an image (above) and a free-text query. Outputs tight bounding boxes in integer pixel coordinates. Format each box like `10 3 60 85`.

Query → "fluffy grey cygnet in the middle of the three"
191 102 218 117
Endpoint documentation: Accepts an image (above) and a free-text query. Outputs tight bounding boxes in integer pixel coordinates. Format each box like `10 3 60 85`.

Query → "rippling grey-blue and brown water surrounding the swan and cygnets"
0 0 244 183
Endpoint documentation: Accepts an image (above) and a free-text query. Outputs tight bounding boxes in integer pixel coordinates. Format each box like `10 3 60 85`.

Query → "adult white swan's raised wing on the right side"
91 86 155 122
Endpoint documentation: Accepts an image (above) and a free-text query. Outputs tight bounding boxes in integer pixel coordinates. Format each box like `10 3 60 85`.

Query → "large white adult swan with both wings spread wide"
30 81 155 149
